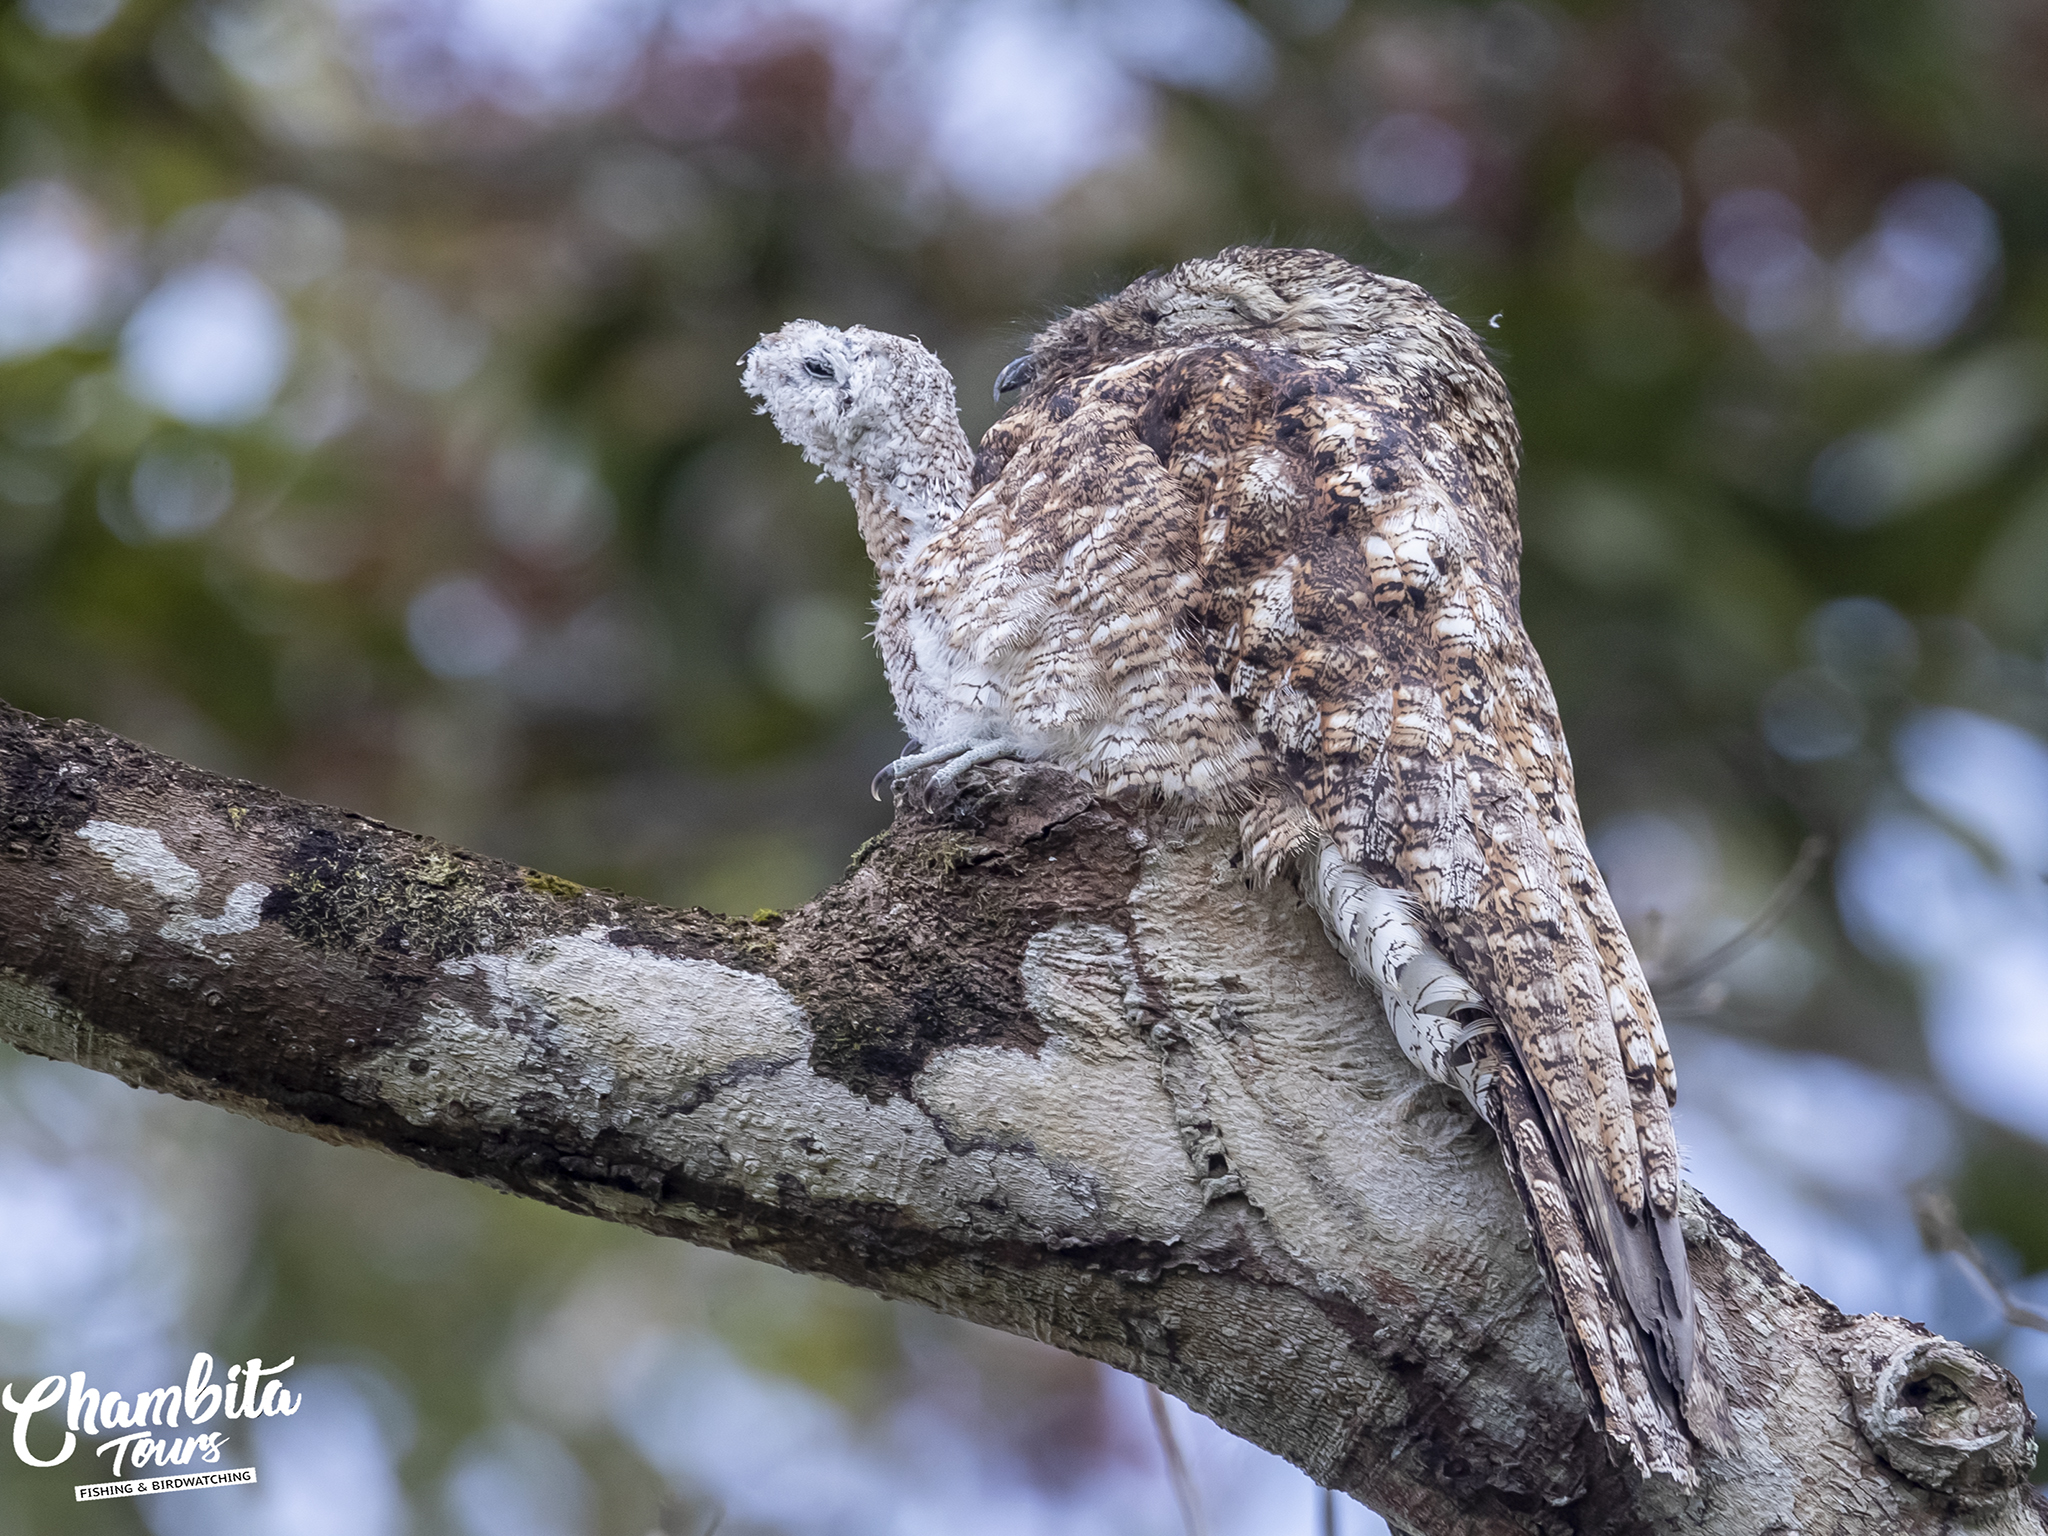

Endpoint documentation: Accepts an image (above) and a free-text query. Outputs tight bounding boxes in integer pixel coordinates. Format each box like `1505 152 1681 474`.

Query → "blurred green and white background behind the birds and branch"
0 0 2048 1536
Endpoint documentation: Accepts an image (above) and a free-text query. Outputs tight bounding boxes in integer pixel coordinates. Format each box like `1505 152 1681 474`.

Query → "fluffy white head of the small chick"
739 319 965 483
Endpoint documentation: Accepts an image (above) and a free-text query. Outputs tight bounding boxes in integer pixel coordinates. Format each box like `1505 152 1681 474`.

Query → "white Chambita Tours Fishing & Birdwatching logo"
0 1354 305 1503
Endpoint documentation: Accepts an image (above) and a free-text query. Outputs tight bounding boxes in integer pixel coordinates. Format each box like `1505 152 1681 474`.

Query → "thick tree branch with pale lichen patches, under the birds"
0 707 2048 1536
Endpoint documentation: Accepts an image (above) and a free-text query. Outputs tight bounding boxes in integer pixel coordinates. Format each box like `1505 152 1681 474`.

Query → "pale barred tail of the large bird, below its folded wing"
1303 840 1724 1487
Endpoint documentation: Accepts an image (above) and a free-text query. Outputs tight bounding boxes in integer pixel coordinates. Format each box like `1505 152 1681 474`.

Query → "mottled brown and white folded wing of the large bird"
1105 333 1694 1433
